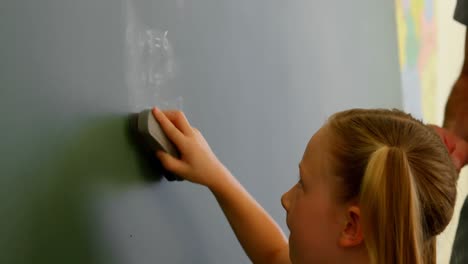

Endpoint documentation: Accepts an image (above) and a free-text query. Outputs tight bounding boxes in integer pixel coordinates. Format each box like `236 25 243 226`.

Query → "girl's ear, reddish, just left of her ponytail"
339 205 364 247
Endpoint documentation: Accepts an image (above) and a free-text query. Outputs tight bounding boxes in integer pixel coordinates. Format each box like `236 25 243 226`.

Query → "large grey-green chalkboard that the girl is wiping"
0 0 402 264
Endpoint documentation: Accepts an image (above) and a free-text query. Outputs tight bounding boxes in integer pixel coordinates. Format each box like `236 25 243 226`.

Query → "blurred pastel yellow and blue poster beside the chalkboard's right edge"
396 0 437 120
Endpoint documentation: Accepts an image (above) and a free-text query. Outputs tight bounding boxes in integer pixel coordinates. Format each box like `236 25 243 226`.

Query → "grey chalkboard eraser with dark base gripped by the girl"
137 110 182 181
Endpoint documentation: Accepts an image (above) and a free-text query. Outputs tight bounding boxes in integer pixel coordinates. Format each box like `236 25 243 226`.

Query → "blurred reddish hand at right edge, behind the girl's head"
429 125 468 172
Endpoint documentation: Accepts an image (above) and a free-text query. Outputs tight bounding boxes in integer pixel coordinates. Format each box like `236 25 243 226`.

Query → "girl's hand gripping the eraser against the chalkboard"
153 108 230 188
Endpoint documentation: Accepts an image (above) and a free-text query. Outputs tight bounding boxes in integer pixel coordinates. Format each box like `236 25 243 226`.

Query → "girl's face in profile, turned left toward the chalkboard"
281 126 346 263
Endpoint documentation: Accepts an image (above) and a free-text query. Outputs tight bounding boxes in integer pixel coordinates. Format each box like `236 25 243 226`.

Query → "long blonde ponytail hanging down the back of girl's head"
360 146 424 264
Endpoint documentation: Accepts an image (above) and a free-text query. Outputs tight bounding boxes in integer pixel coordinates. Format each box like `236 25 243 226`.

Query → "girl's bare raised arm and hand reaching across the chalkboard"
153 108 290 264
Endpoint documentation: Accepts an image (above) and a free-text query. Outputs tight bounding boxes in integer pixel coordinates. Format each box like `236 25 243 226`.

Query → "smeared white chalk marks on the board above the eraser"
124 0 183 111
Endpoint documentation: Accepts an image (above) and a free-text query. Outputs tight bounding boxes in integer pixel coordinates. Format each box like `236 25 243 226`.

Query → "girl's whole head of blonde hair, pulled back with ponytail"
328 109 458 264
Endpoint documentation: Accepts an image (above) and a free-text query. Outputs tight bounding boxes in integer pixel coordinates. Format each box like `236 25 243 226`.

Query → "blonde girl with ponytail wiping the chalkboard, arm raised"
153 108 458 264
